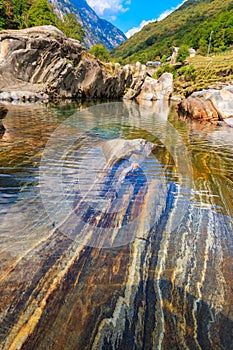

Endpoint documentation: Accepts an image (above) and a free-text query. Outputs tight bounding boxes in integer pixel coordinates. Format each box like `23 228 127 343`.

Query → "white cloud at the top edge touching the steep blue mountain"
87 0 131 17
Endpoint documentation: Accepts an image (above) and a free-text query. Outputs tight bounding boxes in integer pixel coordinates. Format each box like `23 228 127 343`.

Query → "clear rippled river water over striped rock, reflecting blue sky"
0 102 233 349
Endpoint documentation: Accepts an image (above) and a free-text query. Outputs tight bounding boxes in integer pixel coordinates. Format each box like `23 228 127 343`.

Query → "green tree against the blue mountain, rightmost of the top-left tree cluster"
56 13 85 42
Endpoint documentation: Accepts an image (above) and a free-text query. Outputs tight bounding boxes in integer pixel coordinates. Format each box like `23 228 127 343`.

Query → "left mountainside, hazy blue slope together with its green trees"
0 0 126 49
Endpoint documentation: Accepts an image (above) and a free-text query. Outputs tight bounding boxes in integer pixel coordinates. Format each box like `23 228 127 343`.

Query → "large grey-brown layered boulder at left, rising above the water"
0 26 130 101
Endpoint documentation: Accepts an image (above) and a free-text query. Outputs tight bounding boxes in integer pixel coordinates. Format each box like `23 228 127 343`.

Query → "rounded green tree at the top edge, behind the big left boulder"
28 0 57 27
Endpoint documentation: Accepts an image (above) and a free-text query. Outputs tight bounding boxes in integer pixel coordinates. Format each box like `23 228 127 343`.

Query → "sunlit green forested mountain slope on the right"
112 0 233 63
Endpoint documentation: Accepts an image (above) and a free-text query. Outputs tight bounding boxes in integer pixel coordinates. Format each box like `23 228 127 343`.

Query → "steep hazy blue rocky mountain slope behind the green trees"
49 0 126 50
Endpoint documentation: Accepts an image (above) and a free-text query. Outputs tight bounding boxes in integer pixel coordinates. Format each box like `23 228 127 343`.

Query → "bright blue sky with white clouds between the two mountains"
87 0 185 37
